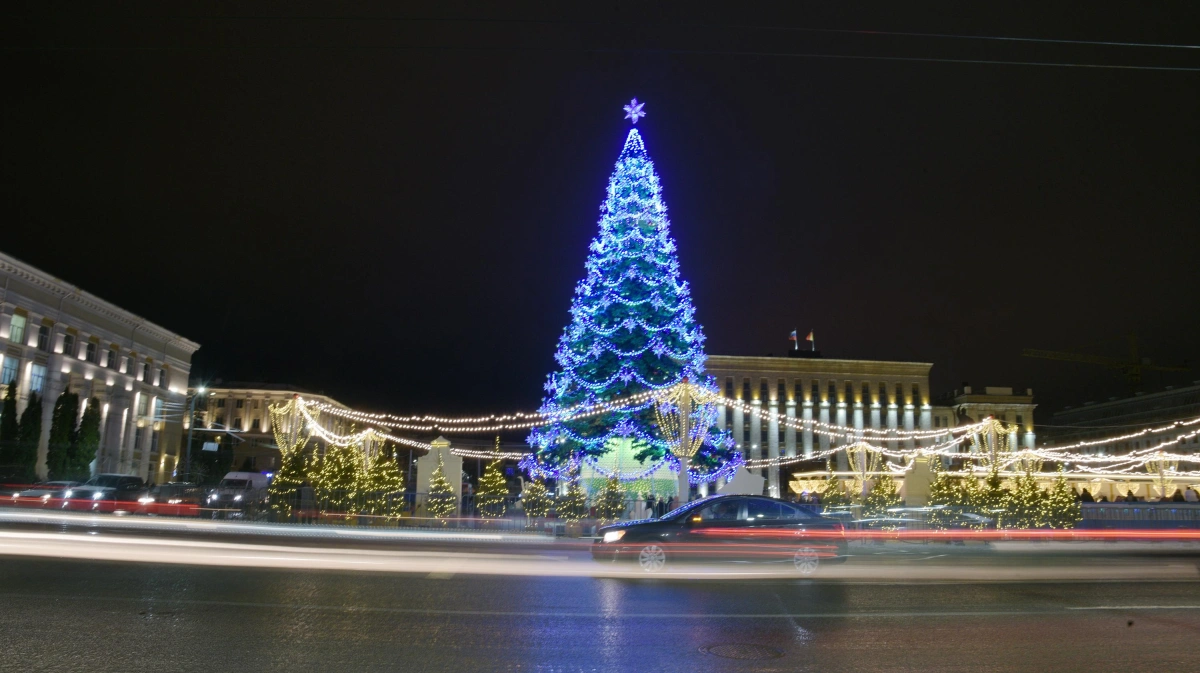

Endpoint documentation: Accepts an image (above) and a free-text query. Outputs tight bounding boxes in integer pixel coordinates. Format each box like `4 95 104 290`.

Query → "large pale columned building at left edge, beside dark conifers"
0 253 200 482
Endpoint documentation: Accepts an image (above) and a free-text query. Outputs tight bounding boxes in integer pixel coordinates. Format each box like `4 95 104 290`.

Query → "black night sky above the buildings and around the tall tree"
0 1 1200 422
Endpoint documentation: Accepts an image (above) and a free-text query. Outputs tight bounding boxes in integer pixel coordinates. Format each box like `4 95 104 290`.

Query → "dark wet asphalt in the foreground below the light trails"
0 557 1200 673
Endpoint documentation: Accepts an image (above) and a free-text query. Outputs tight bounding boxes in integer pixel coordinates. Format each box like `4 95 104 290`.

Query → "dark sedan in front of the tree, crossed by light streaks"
592 495 846 575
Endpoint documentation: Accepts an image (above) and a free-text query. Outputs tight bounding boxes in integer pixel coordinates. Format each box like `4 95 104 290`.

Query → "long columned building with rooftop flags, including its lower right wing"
706 350 1034 495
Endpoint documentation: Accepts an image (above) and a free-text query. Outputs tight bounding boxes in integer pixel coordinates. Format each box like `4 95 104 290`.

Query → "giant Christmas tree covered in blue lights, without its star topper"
528 120 733 487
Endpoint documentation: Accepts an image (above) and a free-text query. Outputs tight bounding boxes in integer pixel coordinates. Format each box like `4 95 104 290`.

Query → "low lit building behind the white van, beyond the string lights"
185 383 349 473
